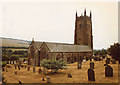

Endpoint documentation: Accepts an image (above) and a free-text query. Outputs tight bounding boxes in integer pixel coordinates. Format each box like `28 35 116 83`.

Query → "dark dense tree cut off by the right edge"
108 43 120 63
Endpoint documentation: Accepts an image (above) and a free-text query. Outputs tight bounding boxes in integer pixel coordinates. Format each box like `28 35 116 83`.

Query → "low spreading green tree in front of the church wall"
41 59 67 72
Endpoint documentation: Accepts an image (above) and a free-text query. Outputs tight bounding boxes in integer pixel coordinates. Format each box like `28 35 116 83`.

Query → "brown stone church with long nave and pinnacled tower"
28 9 93 66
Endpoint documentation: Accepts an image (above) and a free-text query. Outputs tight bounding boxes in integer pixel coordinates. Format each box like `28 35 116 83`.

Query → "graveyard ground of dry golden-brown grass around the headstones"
2 59 118 83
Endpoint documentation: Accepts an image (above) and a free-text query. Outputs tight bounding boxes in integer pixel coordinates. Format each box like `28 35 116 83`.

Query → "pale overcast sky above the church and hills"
0 1 118 49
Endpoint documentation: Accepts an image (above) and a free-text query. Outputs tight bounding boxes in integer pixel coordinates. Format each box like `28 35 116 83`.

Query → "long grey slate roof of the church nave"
34 42 92 52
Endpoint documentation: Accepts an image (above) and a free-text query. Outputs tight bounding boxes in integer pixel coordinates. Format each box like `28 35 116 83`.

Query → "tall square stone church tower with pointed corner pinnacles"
74 9 93 49
